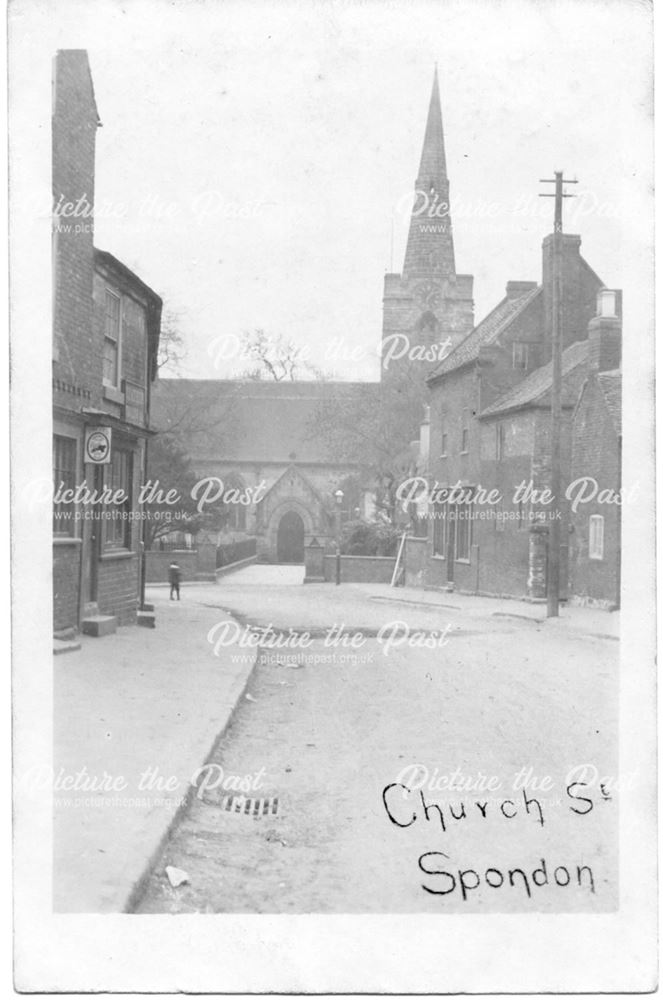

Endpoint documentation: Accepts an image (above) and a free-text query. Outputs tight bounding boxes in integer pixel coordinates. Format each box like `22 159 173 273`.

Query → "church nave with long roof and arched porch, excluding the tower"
153 379 377 563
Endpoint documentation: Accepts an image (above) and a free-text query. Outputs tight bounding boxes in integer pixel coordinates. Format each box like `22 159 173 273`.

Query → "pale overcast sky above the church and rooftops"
13 0 651 378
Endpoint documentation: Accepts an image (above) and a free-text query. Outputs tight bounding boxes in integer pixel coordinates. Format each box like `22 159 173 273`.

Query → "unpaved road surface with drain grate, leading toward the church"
136 567 618 913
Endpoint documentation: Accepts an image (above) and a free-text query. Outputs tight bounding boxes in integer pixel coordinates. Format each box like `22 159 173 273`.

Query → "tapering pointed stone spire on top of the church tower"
403 66 456 282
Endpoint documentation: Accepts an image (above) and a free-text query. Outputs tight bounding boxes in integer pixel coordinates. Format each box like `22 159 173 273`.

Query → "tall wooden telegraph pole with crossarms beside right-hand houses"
539 170 578 618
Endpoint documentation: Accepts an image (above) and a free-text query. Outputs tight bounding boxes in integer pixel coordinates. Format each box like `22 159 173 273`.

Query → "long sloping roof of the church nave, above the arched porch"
151 378 379 465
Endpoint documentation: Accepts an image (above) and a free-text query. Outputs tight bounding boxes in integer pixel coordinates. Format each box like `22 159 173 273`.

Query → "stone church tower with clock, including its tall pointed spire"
382 68 474 376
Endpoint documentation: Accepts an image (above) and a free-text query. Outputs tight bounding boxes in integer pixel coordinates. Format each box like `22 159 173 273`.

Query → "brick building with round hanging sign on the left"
52 50 161 632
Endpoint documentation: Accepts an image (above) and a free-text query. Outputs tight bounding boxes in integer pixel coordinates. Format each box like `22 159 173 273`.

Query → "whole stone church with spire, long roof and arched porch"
152 71 474 562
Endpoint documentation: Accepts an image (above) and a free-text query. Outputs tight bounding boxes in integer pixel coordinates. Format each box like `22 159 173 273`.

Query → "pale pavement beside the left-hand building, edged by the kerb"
51 584 255 913
